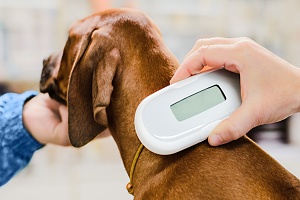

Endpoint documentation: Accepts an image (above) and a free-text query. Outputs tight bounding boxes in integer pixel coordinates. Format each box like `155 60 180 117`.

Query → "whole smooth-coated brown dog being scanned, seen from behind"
44 9 300 200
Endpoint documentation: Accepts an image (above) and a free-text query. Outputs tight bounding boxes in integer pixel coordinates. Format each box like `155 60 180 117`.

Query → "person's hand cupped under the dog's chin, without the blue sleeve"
23 94 70 146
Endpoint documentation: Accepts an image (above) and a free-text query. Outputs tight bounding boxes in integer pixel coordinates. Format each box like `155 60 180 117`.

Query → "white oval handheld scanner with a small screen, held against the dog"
135 69 241 155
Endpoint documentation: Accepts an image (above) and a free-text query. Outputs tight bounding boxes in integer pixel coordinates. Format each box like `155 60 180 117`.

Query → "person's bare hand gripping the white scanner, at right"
171 38 300 146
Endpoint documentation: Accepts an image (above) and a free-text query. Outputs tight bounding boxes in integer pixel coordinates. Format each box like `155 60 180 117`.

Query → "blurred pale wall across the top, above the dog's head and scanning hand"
0 0 300 81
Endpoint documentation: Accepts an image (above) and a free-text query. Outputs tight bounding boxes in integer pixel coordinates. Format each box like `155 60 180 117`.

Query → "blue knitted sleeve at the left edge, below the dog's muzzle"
0 91 43 186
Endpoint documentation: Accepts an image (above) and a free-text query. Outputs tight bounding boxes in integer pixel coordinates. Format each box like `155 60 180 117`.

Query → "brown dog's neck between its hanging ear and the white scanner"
107 52 179 173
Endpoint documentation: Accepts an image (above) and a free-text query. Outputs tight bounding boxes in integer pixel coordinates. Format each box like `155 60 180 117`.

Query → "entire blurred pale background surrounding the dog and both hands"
0 0 300 200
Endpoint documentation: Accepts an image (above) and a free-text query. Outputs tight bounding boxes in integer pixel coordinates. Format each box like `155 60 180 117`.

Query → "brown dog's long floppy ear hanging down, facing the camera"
68 28 120 147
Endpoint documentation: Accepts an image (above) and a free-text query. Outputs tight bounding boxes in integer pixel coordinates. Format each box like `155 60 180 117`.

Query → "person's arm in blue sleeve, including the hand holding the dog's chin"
0 91 69 186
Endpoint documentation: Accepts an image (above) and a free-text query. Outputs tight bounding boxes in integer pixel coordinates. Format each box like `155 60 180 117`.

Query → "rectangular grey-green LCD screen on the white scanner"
170 85 226 121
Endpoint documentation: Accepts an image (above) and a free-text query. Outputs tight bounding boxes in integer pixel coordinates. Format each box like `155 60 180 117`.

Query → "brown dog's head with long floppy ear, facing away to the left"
41 9 177 147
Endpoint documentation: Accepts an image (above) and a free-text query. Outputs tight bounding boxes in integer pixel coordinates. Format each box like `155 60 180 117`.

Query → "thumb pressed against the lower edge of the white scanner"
208 105 256 146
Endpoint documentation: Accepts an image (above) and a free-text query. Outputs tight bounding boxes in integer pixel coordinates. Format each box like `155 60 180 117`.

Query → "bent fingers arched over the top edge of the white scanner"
170 38 255 84
